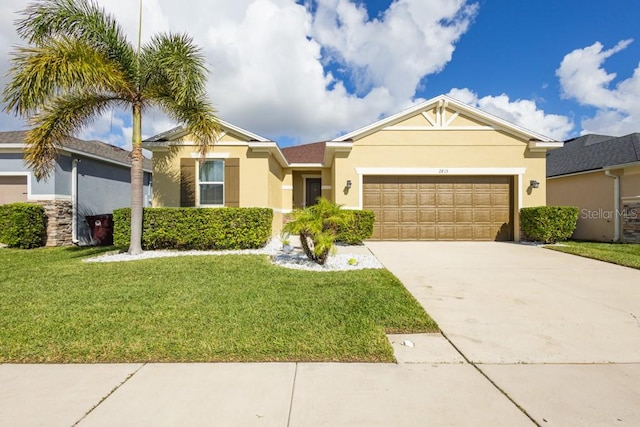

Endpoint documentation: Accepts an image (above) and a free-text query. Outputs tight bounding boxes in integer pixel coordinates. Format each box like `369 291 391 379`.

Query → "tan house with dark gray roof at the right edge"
547 133 640 243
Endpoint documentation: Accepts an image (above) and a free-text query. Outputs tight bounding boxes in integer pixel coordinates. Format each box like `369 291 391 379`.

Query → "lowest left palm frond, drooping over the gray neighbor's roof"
24 91 125 179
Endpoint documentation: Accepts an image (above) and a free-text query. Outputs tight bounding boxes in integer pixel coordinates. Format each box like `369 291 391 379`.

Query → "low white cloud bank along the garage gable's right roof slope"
448 88 573 141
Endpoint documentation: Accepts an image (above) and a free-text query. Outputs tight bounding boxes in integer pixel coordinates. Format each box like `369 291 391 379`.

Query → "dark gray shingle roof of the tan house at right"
547 133 640 177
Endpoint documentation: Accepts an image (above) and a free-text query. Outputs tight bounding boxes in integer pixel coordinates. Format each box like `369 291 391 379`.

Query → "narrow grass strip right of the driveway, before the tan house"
547 242 640 269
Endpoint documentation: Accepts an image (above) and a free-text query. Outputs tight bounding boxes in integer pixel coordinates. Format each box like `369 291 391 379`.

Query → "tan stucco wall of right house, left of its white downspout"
547 171 616 242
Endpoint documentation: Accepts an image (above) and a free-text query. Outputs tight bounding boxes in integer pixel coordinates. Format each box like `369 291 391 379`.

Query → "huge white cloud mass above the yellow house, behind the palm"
0 0 477 145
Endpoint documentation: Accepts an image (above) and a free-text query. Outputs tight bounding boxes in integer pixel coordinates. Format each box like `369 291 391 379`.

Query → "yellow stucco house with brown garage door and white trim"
143 95 562 240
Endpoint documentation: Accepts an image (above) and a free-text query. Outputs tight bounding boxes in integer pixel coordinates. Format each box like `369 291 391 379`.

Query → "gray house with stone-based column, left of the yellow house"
0 131 151 246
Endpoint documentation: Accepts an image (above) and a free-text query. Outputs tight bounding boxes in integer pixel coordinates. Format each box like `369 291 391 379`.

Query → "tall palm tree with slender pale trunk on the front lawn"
4 0 219 254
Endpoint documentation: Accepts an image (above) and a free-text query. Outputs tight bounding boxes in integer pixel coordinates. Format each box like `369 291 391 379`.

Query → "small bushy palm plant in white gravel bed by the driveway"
284 197 342 265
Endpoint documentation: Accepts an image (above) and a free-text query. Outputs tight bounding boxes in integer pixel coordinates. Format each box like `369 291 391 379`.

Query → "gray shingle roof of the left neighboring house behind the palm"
0 131 152 171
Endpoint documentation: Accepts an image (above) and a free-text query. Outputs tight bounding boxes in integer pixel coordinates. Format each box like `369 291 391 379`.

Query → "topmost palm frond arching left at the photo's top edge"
16 0 137 80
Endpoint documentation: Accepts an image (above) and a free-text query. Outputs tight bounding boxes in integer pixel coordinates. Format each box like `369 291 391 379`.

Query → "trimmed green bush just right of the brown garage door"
520 206 579 243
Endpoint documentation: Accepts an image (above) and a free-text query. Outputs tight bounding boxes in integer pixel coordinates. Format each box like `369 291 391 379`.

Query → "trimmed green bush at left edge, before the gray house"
0 203 47 249
